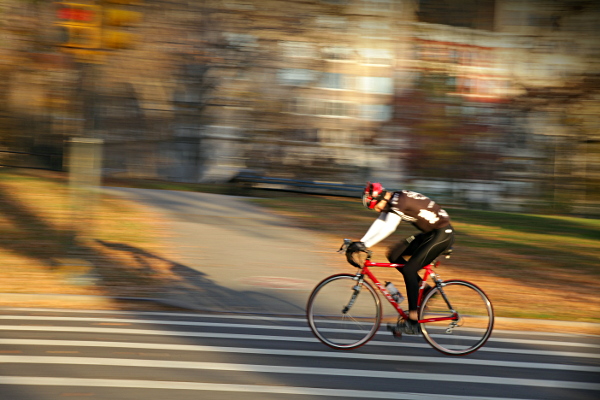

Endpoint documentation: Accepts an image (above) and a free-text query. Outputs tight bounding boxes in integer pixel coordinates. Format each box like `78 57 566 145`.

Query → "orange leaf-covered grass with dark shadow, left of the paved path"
0 168 171 296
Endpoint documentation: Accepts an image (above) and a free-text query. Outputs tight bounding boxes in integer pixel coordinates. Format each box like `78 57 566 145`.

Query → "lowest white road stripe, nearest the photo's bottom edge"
0 376 536 400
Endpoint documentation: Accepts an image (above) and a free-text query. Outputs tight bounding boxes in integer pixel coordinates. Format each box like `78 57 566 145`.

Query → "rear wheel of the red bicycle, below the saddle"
419 280 494 356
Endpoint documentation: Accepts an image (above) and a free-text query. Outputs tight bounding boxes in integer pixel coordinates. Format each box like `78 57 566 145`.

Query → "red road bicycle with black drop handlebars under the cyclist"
306 239 494 355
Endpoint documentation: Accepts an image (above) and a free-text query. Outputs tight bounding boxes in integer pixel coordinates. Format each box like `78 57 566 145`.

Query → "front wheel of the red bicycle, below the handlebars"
306 274 381 350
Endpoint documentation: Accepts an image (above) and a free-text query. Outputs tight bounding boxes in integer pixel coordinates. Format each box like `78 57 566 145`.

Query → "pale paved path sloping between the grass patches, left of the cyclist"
105 188 346 315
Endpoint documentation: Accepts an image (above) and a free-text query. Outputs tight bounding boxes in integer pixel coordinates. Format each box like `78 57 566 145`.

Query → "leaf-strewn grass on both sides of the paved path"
0 170 600 322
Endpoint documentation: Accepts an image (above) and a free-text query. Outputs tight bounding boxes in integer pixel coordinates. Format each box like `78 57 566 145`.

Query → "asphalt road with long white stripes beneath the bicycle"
0 308 600 400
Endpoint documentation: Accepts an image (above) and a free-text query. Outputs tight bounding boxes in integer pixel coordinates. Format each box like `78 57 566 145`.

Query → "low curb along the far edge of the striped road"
0 293 600 335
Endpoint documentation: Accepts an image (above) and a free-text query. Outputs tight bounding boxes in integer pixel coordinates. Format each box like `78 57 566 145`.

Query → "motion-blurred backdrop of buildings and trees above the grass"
0 0 600 217
